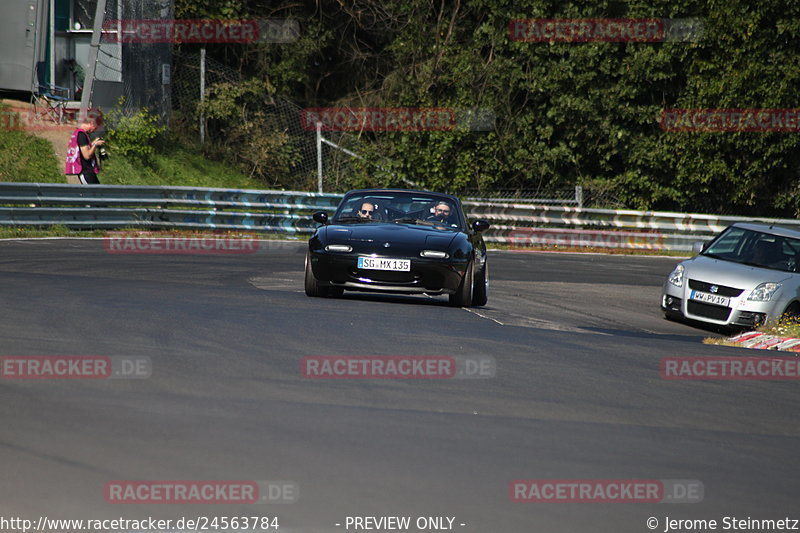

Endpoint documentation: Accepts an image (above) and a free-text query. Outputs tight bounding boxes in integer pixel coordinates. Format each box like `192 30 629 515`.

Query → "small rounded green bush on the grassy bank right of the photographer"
106 99 166 162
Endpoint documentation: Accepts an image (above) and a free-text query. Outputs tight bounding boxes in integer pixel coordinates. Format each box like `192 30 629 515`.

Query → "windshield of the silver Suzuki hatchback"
702 227 800 272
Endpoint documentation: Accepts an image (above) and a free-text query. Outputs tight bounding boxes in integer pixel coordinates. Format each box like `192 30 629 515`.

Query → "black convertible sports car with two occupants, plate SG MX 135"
305 189 489 307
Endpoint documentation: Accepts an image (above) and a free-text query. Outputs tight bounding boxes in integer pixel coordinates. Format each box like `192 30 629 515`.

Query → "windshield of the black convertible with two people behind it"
331 191 465 230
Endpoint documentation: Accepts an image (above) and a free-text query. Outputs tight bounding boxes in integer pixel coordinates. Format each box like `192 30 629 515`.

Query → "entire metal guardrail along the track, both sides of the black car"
0 183 800 251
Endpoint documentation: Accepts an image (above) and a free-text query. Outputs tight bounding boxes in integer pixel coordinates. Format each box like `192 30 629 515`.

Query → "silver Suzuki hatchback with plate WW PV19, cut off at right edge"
661 223 800 328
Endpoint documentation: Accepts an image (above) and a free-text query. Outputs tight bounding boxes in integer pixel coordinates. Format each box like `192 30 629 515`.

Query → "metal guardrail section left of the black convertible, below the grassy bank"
0 183 343 233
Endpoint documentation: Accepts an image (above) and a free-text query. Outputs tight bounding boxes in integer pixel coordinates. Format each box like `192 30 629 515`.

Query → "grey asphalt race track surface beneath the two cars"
0 240 800 533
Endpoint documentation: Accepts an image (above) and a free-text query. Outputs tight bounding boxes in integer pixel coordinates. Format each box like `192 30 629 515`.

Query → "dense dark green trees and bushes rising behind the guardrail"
176 0 800 216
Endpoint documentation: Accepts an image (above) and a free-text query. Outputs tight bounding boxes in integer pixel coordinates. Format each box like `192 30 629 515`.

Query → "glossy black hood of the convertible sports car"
325 222 459 249
